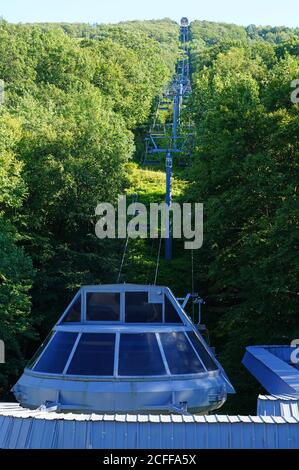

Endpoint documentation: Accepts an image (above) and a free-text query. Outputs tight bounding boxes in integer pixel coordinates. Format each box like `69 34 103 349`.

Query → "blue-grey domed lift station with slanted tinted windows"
13 284 233 413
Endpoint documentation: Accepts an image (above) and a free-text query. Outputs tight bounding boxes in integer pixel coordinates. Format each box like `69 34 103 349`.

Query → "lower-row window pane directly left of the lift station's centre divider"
67 333 115 376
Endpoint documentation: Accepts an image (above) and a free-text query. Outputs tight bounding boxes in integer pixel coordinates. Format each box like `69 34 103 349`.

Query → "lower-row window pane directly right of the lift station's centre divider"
118 333 166 376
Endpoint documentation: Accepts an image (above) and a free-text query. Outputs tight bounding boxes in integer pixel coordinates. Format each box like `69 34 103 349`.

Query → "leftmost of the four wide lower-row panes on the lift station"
33 332 77 374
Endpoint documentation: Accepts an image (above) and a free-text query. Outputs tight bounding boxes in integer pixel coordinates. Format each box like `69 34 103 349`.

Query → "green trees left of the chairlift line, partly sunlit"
0 21 176 391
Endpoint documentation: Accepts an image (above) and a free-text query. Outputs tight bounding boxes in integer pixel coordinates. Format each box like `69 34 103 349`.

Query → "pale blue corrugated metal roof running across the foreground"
0 399 299 449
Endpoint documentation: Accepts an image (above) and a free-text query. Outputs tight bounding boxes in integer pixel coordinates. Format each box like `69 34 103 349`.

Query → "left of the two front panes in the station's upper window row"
86 292 120 322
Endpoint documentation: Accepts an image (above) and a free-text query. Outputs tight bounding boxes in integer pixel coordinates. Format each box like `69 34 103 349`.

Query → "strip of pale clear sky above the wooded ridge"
0 0 299 26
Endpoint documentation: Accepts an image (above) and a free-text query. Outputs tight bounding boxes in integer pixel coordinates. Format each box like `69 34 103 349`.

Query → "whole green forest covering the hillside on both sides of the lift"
0 19 299 413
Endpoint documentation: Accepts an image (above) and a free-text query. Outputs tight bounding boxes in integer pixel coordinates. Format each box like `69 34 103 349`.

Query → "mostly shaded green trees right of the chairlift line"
189 21 299 412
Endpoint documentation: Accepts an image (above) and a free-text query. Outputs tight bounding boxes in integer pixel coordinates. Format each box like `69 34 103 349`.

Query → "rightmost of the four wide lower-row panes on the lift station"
160 333 205 375
